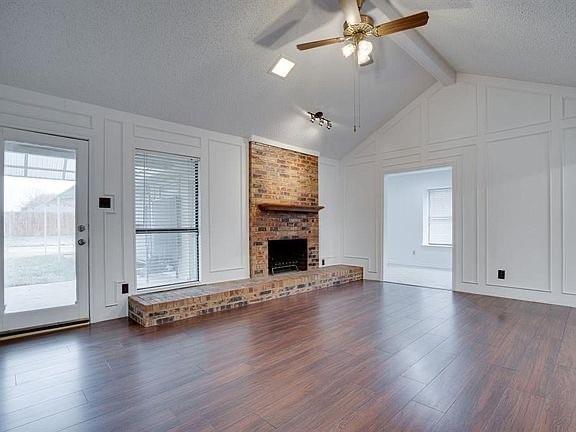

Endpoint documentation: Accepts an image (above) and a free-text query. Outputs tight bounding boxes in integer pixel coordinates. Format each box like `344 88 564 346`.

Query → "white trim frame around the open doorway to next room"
380 159 462 291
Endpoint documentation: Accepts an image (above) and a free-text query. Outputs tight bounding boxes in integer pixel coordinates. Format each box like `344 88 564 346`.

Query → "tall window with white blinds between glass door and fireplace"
134 150 200 289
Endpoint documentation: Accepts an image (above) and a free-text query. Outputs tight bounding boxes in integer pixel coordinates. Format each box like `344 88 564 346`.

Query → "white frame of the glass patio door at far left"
0 127 90 333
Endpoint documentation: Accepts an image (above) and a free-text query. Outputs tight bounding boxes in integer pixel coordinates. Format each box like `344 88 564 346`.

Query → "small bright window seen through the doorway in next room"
425 188 452 246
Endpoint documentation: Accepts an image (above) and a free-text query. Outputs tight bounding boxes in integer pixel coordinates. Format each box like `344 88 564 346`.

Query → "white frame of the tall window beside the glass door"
131 147 203 294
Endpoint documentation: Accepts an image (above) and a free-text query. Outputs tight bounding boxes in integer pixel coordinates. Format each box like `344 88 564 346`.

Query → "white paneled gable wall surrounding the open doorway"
342 74 576 306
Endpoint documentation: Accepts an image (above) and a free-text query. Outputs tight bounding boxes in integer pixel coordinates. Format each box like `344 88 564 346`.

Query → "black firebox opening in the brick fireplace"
268 239 308 275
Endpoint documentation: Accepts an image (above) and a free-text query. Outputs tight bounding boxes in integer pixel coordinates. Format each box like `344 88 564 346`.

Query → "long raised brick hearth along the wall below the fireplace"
128 265 363 327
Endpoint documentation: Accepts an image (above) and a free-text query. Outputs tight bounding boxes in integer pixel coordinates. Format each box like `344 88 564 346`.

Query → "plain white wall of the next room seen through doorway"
383 168 452 270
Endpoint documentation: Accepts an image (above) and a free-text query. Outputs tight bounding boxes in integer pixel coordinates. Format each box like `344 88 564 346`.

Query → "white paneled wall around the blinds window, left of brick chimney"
0 85 249 321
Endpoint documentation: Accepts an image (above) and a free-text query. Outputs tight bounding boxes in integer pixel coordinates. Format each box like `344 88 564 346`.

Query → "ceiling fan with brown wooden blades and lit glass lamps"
296 0 428 66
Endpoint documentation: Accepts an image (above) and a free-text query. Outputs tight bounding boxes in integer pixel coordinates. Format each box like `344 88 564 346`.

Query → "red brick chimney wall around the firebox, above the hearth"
250 142 319 276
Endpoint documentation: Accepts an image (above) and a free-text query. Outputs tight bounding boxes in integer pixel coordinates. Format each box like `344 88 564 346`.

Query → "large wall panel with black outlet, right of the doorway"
486 133 550 291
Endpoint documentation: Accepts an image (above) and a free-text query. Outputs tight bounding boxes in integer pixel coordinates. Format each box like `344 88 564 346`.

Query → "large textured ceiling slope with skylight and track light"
0 0 434 157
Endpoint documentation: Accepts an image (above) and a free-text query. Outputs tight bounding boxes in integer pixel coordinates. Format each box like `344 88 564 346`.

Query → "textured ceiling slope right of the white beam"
391 0 576 86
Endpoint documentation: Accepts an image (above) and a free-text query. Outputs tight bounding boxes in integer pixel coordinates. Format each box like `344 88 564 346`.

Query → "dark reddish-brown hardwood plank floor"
0 282 576 432
